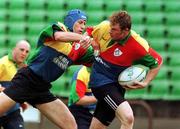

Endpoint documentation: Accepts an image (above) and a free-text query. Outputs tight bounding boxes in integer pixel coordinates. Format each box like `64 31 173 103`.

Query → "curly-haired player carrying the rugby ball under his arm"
87 11 162 129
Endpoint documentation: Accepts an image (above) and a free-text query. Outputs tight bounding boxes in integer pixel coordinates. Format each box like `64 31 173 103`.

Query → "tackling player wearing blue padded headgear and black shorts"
0 9 94 129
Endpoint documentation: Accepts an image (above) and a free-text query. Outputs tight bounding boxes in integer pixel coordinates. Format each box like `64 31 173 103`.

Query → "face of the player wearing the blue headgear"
73 19 86 34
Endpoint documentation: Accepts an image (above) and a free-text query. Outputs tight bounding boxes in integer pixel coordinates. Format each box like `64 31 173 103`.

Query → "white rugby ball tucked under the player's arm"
118 65 148 86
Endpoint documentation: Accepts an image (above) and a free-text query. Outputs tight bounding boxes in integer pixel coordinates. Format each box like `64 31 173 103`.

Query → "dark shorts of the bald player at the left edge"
0 110 24 129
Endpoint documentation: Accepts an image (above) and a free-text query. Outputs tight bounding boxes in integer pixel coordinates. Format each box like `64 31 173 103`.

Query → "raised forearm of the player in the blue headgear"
54 32 83 42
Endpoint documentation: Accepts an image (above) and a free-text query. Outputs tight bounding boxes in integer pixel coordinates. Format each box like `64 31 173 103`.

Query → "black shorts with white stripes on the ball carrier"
91 83 125 126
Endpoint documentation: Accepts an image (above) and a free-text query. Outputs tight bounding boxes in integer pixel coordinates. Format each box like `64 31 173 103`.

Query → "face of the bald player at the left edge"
14 44 30 63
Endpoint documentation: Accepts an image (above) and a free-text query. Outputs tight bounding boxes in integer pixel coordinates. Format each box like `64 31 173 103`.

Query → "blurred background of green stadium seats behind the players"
0 0 180 129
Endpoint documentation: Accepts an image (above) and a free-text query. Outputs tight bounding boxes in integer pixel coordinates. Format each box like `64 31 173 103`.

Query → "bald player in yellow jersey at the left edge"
0 40 30 129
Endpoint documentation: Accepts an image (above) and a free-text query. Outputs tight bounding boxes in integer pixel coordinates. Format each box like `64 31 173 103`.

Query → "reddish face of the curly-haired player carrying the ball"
110 24 128 40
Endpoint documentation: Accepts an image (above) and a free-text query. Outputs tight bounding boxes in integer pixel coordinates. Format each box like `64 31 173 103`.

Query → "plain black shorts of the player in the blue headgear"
3 67 57 106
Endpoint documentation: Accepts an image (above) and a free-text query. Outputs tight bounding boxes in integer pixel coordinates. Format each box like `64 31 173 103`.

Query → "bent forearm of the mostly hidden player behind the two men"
76 95 97 105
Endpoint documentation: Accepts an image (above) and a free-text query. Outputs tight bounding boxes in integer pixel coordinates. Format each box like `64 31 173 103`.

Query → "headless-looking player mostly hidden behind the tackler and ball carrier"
68 66 97 129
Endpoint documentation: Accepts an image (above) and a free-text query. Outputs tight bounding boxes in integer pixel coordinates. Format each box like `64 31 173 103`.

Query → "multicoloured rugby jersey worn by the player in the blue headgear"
28 22 93 82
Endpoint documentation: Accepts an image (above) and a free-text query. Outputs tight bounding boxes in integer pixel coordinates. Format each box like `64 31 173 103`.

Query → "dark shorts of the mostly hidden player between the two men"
69 106 93 129
